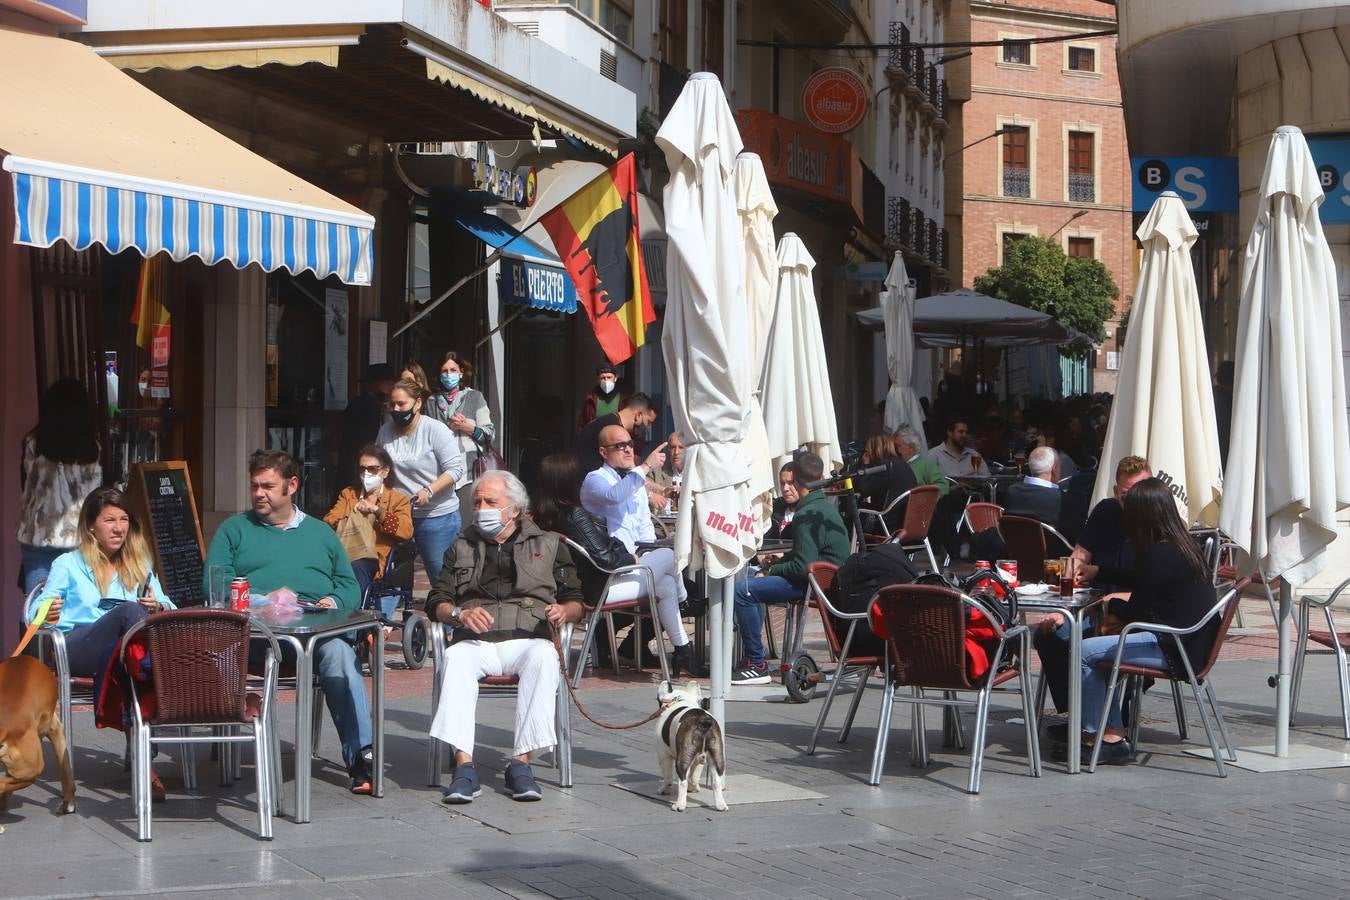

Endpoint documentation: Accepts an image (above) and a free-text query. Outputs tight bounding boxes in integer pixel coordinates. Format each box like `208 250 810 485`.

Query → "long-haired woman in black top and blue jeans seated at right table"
1083 478 1219 765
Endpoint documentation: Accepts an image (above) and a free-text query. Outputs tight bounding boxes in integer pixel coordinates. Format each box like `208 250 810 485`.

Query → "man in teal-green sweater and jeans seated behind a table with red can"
205 451 374 793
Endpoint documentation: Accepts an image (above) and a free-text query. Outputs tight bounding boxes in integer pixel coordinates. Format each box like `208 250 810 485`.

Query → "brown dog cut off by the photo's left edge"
0 656 76 812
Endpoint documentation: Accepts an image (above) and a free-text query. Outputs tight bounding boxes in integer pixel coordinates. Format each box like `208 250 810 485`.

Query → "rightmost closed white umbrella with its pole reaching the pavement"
1219 125 1350 757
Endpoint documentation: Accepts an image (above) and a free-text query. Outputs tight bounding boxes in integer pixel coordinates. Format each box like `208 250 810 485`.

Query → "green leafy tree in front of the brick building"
975 237 1121 355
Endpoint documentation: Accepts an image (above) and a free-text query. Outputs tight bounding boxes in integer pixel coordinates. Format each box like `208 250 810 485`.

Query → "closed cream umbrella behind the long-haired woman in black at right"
1092 190 1223 526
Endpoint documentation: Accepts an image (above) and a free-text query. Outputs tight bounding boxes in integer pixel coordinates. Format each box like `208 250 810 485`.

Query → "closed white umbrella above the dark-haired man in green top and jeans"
760 232 844 471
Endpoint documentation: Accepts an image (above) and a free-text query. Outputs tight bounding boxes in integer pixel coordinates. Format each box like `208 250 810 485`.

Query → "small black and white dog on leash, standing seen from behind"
656 681 726 812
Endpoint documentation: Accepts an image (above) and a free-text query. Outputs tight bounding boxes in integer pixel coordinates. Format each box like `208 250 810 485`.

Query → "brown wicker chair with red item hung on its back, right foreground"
868 584 1041 793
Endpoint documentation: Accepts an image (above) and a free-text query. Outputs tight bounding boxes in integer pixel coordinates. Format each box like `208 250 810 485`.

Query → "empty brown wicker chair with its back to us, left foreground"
117 609 281 841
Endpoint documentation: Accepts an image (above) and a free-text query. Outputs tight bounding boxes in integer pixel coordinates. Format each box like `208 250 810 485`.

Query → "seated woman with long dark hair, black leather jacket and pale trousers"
535 453 699 677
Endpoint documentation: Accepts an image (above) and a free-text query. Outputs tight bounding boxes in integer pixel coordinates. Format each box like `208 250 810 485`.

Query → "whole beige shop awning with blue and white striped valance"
0 30 375 285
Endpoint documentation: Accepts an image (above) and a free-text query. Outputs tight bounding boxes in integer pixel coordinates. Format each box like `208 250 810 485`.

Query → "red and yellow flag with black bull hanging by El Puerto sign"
539 154 656 363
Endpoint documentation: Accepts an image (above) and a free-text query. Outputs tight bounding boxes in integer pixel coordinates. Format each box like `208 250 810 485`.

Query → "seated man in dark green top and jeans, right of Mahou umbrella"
732 453 849 684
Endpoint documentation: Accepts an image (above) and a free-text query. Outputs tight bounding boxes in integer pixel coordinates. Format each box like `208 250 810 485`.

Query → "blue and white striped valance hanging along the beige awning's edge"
4 157 374 285
